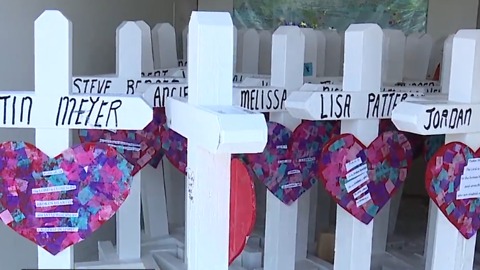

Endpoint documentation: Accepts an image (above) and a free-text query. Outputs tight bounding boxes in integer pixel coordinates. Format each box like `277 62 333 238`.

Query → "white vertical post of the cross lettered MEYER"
35 10 74 269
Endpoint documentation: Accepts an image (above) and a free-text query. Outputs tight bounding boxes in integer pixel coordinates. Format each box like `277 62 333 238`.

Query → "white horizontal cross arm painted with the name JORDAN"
392 100 480 135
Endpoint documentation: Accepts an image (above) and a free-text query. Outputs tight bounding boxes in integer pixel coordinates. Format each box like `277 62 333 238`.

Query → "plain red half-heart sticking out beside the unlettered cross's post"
229 158 256 263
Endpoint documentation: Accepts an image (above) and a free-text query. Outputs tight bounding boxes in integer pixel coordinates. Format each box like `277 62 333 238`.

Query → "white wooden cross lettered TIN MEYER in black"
6 10 151 269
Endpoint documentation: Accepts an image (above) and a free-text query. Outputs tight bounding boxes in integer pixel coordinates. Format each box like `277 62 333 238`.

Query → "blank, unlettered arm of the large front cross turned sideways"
166 98 268 154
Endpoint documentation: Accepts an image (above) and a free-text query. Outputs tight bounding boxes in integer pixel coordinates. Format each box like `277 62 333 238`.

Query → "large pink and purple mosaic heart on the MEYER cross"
0 142 133 255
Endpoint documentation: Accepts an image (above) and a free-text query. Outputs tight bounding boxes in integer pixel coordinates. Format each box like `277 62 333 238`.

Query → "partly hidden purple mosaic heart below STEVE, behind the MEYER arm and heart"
78 108 166 175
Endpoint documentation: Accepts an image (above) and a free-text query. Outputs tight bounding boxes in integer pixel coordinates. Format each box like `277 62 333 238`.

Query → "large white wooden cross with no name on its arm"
166 12 268 270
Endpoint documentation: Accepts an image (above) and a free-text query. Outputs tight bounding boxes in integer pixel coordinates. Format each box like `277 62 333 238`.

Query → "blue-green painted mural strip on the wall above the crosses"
234 0 428 33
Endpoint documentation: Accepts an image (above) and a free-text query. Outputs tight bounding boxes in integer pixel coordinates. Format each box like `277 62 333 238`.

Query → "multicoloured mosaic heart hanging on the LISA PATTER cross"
320 131 413 224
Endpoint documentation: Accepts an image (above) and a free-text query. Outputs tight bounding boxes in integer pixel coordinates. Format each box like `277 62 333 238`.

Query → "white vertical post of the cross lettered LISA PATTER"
334 24 383 270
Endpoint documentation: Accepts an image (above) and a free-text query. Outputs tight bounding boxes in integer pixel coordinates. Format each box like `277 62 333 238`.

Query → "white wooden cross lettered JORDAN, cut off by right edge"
392 30 480 270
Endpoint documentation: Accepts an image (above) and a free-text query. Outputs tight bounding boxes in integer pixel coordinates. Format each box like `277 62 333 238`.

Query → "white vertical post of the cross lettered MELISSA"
263 26 309 270
